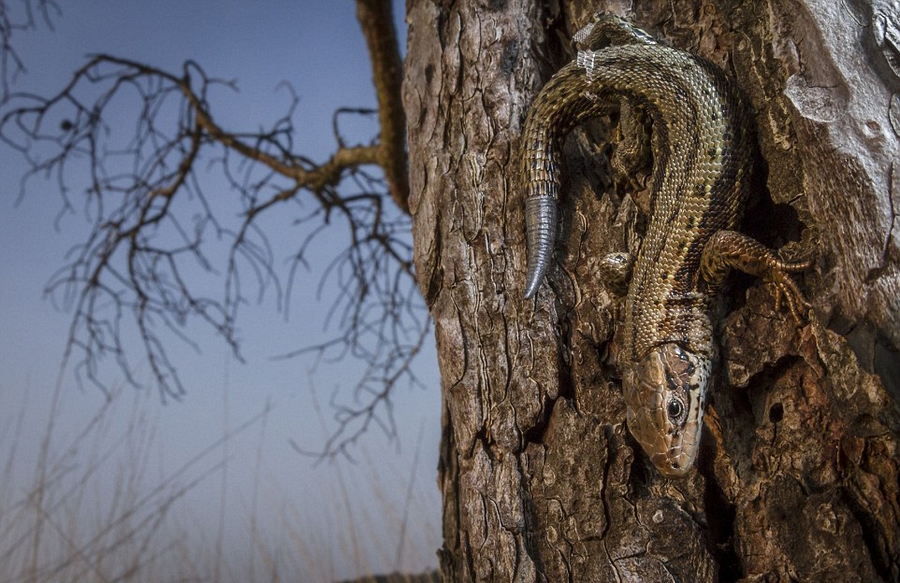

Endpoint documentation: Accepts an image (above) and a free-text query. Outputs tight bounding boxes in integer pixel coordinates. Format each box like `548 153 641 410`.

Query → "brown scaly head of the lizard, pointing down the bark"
623 342 711 478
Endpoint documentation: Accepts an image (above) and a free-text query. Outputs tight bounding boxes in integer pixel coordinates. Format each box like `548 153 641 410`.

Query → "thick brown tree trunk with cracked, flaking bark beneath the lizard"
404 0 900 582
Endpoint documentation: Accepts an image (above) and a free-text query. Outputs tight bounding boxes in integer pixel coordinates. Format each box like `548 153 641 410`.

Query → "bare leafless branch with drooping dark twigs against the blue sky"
0 0 420 453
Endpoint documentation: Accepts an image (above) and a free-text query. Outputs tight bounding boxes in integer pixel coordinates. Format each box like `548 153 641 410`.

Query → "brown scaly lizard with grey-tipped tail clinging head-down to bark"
521 13 810 478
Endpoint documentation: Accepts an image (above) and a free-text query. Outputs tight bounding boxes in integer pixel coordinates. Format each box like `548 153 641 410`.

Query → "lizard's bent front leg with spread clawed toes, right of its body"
700 231 810 324
